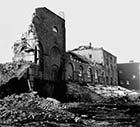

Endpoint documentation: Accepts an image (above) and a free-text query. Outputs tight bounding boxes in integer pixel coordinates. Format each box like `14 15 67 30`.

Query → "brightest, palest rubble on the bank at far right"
87 84 140 105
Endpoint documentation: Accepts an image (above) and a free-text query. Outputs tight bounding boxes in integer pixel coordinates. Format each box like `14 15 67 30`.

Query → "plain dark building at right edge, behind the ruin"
118 62 140 90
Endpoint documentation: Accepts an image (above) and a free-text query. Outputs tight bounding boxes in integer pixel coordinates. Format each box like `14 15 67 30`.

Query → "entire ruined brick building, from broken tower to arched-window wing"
13 8 117 96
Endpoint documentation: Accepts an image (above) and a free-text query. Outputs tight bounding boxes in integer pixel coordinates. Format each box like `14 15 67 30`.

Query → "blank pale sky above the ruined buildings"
0 0 140 63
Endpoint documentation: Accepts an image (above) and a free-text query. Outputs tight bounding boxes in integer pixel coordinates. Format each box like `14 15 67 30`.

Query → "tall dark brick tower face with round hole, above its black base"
32 8 65 81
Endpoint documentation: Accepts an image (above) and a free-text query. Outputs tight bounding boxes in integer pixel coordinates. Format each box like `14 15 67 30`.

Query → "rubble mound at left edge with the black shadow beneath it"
0 62 31 98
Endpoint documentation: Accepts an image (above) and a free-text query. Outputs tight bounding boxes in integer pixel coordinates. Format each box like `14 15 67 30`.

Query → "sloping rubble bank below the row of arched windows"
66 83 140 105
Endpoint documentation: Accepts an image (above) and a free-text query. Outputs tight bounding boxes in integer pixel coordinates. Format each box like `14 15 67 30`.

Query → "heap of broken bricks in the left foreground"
0 93 75 126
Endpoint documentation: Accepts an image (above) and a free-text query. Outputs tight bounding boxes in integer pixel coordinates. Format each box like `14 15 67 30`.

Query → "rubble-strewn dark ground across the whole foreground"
0 84 140 127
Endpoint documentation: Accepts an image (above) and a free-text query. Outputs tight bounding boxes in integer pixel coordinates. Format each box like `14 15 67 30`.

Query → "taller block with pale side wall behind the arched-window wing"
72 44 118 85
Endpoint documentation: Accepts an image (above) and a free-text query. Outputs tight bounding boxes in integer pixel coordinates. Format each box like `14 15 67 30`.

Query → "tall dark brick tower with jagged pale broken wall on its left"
5 8 65 97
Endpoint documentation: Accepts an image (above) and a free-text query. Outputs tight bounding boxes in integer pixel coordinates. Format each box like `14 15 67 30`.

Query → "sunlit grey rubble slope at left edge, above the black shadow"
0 61 31 86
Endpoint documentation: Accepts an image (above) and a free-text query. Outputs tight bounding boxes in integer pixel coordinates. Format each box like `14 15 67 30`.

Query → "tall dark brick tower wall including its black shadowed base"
32 8 66 98
